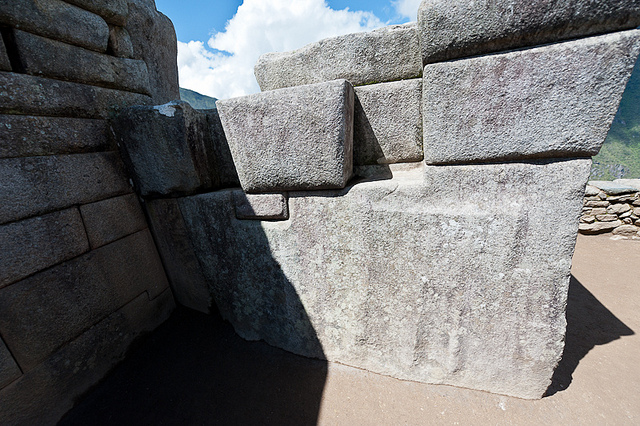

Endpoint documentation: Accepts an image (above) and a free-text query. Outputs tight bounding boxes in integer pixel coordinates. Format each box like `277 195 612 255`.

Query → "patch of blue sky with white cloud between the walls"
156 0 421 99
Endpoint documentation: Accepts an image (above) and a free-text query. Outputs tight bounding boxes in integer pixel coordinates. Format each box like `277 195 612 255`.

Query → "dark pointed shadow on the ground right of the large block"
545 275 634 396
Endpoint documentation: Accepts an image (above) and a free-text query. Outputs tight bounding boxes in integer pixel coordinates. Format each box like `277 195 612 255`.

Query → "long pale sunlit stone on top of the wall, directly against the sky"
254 23 422 91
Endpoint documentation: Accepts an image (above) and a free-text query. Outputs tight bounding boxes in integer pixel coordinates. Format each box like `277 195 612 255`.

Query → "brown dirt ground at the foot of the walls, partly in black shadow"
61 236 640 425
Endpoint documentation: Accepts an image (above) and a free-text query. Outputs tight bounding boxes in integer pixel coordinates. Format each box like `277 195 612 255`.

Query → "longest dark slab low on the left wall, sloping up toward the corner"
0 230 169 372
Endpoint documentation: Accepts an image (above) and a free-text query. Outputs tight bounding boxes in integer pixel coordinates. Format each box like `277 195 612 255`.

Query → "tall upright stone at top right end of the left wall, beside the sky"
126 0 180 105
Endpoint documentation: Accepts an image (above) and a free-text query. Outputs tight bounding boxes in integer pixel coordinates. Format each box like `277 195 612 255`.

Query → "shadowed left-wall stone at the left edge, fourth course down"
0 114 111 158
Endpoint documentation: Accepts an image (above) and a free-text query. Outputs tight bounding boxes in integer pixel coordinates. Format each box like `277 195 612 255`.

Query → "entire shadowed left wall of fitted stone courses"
0 0 178 424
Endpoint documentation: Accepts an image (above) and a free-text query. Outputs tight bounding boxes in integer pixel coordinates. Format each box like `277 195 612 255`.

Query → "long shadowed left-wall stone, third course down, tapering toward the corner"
0 72 151 118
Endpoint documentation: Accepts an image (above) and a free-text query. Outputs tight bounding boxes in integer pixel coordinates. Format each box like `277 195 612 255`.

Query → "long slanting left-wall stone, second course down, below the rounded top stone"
14 30 151 95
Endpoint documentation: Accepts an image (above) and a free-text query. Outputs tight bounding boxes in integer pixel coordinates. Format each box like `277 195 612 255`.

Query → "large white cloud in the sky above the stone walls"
178 0 384 99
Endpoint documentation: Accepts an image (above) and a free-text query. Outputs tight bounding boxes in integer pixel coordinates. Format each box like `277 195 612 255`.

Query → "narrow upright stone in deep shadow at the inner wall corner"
145 199 214 313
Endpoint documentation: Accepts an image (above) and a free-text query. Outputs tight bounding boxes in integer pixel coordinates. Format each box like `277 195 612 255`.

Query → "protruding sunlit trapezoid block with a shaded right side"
216 80 354 192
